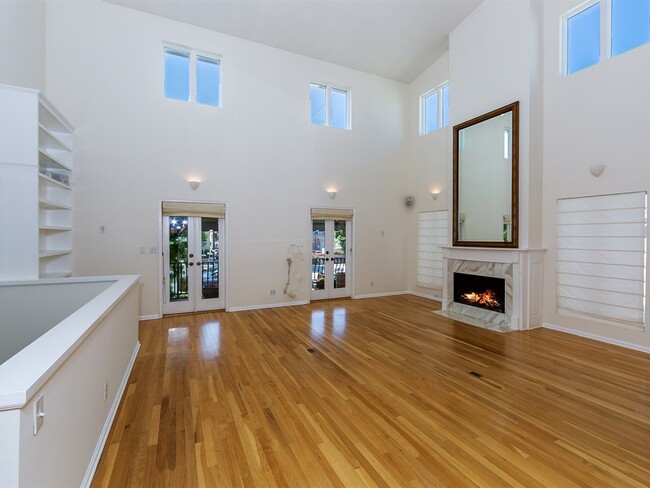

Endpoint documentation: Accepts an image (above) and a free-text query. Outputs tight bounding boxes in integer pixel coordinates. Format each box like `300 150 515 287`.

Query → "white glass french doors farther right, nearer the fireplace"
311 219 352 300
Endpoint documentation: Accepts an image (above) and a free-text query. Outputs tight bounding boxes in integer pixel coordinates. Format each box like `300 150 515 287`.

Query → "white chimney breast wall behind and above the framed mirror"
449 0 542 249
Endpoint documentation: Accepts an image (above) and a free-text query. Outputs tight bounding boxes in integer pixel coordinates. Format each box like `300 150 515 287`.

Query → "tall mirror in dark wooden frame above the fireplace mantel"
452 102 519 247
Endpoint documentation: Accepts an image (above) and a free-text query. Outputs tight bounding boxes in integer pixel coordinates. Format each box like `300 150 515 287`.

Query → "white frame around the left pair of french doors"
158 198 230 320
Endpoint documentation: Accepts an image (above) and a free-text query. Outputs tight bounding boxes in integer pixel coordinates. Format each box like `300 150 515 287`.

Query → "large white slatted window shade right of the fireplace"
557 192 647 328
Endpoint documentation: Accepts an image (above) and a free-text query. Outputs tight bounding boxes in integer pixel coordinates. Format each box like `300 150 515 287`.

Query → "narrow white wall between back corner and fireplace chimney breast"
406 54 454 298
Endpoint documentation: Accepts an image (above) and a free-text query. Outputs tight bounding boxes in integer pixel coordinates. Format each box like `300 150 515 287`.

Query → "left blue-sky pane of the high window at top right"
567 3 600 75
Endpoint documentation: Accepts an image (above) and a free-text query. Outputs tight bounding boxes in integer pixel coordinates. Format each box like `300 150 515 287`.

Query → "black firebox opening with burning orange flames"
454 273 506 313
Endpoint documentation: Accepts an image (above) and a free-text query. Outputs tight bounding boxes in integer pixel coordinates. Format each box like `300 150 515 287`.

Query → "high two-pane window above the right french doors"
309 83 350 129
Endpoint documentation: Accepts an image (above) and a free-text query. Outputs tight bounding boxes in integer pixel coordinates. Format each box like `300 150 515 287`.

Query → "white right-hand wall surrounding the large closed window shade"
543 0 650 350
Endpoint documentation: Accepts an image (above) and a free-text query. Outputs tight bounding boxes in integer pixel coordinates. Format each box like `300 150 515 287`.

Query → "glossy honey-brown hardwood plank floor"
93 295 650 488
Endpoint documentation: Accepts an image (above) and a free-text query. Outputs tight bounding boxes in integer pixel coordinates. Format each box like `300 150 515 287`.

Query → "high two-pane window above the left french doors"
163 46 221 107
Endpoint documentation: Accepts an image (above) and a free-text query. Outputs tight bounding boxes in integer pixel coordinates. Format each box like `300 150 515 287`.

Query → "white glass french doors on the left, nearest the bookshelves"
163 215 225 314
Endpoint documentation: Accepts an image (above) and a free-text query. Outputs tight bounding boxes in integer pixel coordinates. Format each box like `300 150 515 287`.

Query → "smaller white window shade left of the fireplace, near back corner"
416 210 449 288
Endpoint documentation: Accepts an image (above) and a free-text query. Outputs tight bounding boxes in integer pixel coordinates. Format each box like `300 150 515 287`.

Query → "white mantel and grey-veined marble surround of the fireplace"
440 247 545 332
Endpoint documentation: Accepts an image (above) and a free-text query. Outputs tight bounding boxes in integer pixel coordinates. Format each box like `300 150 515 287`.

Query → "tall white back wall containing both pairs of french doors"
47 0 406 315
